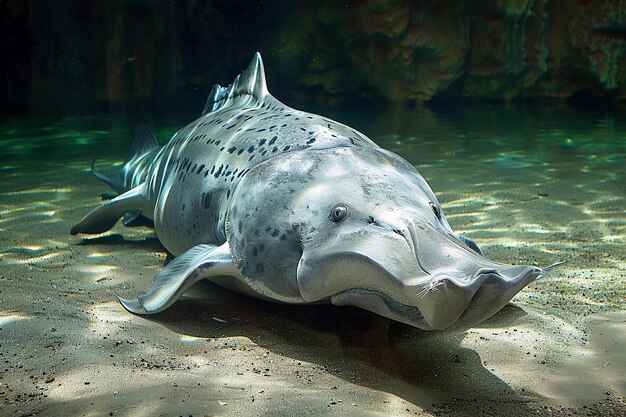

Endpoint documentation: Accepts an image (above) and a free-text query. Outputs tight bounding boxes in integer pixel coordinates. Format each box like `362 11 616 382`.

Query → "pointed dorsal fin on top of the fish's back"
202 52 269 115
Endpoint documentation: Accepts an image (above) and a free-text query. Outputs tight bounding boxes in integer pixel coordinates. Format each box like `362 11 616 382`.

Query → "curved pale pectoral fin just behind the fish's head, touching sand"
115 242 238 314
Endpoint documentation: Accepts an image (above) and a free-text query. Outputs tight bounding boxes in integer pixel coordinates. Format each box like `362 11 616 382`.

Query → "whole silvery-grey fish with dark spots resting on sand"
71 53 560 330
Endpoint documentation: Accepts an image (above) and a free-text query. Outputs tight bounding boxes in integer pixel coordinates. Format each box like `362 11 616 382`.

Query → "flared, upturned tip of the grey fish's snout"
407 265 542 330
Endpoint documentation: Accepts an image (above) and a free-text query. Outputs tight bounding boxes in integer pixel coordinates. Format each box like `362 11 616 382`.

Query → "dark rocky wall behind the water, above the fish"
0 0 626 114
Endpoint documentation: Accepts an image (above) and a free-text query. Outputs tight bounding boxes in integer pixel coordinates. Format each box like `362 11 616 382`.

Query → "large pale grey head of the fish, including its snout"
229 148 542 330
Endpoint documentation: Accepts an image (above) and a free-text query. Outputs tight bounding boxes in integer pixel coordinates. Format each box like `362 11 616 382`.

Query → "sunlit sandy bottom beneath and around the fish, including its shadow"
0 124 626 416
